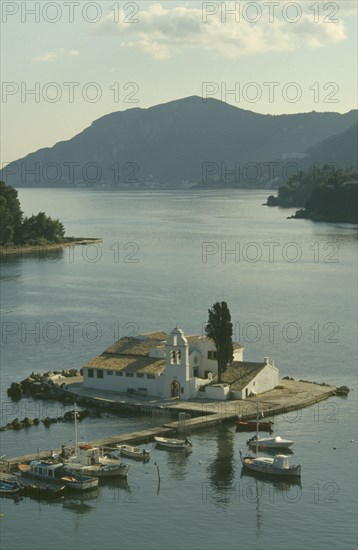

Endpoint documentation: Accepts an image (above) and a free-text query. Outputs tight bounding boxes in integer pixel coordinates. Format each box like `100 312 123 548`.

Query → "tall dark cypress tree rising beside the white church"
205 302 234 383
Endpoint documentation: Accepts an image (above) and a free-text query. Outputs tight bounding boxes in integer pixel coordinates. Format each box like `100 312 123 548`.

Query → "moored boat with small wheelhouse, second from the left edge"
18 460 98 491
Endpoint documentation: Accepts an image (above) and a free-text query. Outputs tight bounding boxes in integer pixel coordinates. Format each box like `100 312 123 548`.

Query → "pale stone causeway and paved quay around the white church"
0 376 340 472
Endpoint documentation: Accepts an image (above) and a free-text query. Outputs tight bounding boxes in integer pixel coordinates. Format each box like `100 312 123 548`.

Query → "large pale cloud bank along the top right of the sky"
93 2 355 59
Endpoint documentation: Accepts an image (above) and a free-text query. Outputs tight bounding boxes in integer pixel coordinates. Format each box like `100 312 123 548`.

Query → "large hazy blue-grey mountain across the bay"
0 96 357 187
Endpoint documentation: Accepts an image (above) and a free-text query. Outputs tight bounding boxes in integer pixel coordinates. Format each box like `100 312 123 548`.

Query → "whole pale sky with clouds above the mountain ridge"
0 0 358 166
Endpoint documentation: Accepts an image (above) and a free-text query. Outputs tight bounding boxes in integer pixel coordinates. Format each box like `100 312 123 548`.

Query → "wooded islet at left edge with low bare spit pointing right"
0 181 102 256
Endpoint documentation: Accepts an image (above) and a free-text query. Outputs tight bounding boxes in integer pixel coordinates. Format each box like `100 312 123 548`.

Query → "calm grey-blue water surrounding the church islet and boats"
1 190 357 550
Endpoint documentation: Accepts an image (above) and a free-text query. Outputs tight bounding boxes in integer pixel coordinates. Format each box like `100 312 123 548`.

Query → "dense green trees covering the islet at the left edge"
0 181 65 246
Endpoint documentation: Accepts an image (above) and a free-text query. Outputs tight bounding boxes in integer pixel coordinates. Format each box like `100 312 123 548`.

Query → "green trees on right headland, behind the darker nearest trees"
267 164 358 208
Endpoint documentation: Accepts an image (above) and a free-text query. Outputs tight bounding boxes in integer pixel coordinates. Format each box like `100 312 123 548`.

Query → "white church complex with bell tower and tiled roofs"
83 327 279 400
